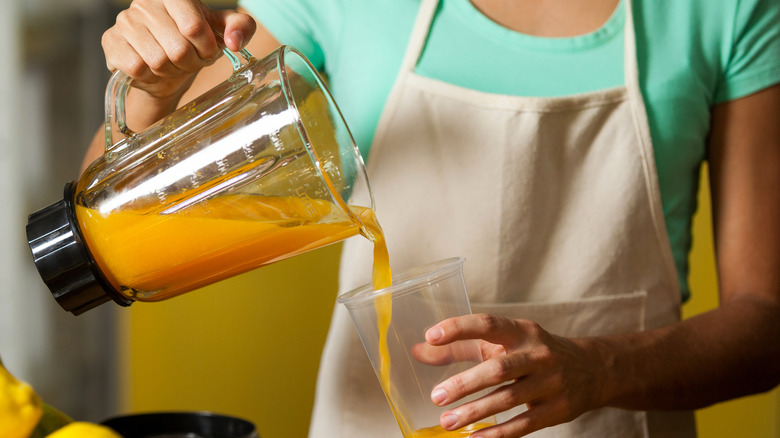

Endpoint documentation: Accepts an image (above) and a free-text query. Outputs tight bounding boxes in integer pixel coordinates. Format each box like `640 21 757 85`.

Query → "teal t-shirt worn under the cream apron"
240 0 780 300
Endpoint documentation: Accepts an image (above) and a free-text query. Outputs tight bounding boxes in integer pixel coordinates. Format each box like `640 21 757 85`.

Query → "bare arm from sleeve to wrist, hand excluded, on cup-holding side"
596 86 780 409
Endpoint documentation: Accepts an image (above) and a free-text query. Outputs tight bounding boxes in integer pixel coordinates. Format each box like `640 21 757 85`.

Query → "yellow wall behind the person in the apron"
119 166 780 438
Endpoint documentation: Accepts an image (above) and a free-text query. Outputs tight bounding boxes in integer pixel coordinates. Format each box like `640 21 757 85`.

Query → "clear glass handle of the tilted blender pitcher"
105 46 254 152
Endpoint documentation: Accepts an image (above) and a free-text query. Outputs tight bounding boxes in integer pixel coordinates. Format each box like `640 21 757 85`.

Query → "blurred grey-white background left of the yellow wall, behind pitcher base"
0 0 122 421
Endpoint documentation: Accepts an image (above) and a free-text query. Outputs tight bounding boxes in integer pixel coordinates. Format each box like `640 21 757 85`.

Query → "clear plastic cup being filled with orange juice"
338 258 495 438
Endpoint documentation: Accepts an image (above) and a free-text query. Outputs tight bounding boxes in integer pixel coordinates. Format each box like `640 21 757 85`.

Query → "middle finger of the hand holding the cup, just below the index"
431 353 532 406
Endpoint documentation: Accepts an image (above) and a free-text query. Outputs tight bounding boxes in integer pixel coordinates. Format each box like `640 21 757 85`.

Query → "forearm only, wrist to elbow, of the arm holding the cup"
592 297 780 410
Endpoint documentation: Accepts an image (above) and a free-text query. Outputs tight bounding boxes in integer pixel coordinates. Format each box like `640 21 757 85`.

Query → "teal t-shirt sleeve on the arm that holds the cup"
715 0 780 103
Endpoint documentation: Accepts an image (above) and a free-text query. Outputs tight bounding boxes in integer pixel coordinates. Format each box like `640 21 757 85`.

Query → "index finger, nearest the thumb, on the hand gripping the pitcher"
165 1 220 60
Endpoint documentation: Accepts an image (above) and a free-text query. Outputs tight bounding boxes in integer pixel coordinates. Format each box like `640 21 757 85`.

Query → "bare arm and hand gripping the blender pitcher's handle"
82 0 279 170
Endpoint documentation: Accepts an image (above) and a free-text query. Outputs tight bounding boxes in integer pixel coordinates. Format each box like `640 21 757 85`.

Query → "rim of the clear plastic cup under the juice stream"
336 257 466 307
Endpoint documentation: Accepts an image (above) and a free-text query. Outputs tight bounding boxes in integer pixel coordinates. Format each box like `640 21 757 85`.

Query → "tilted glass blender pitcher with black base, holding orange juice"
27 46 373 315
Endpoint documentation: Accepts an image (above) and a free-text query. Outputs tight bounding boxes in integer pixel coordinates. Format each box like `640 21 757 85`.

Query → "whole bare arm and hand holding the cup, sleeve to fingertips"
426 85 780 438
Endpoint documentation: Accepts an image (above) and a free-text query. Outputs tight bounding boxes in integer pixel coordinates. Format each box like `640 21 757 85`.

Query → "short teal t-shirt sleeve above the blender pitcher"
238 0 328 70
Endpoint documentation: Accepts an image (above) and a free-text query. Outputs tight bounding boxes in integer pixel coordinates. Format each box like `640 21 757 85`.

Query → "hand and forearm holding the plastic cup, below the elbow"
425 289 780 437
